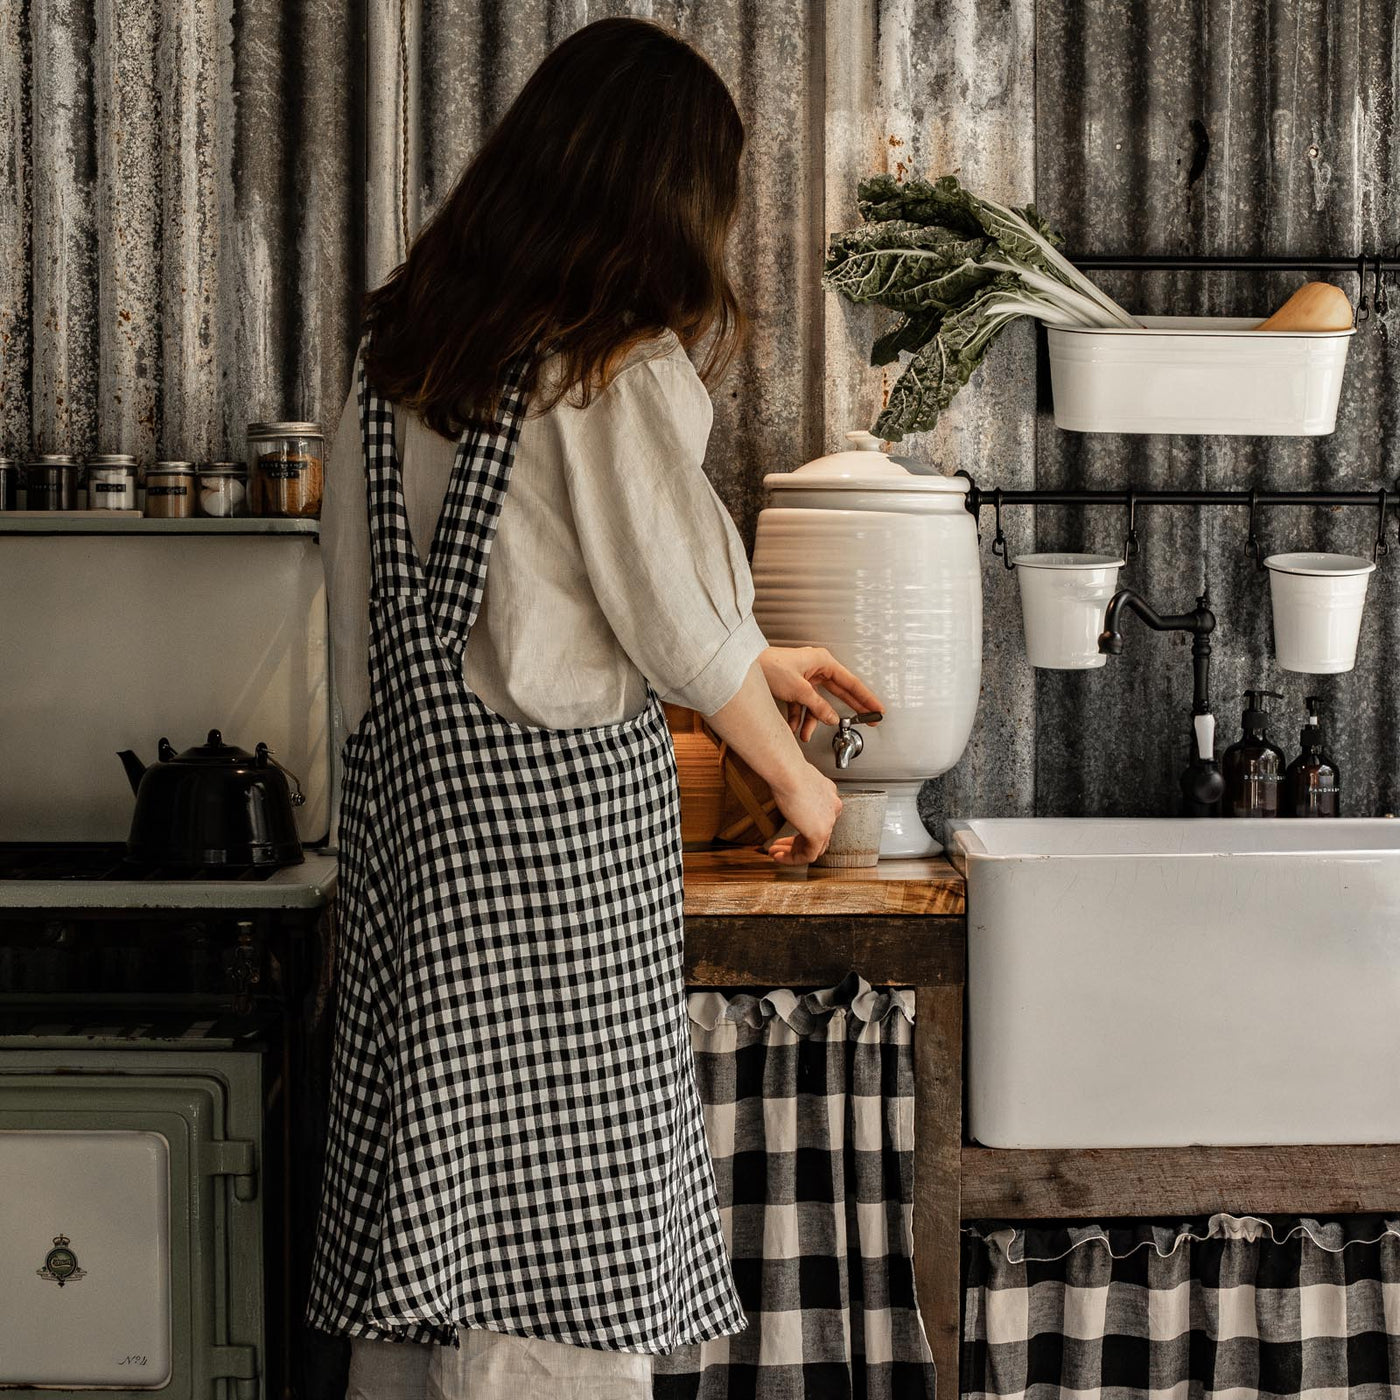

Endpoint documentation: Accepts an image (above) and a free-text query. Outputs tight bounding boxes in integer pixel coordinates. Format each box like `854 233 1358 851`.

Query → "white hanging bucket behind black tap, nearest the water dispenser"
1015 554 1123 671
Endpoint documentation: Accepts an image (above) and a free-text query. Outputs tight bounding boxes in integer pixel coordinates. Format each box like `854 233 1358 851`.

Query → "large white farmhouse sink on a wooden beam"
948 818 1400 1148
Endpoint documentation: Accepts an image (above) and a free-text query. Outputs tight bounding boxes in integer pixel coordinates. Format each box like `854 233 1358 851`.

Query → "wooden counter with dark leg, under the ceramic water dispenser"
685 851 967 1396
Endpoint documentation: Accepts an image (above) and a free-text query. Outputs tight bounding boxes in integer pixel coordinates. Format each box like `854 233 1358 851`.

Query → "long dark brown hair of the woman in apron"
365 18 743 435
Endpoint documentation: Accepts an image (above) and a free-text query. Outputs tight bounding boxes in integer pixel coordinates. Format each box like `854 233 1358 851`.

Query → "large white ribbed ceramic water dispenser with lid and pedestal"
753 433 981 857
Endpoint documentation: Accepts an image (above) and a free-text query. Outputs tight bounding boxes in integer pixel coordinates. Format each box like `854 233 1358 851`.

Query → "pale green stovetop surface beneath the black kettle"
0 841 336 909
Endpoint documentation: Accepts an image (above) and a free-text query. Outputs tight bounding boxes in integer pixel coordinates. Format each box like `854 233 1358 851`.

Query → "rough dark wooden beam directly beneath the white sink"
962 1145 1400 1221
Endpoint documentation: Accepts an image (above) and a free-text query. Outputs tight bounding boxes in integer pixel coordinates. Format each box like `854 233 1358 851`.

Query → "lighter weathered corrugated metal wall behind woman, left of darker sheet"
0 0 1033 813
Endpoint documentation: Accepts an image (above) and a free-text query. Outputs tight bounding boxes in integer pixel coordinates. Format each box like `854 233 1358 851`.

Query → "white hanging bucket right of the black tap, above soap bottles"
1264 553 1376 676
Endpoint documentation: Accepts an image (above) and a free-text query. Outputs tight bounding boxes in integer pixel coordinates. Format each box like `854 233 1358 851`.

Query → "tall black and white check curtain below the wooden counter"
655 974 934 1400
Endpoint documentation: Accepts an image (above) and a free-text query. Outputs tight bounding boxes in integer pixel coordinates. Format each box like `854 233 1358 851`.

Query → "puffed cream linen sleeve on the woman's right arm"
557 349 767 714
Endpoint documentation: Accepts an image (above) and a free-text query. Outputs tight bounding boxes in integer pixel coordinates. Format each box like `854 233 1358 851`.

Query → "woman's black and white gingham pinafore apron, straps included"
308 341 745 1352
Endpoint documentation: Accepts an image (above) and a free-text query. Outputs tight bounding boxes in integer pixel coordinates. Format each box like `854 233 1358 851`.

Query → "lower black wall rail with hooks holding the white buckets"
958 472 1400 568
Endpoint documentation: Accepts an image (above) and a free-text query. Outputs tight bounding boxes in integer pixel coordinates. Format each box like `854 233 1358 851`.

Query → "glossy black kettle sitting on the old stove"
118 729 305 868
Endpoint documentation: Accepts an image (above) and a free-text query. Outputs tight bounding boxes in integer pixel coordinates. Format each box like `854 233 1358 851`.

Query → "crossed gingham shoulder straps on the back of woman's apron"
356 332 526 664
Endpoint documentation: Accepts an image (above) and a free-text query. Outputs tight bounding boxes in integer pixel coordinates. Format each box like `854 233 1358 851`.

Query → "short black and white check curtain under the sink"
962 1215 1400 1400
